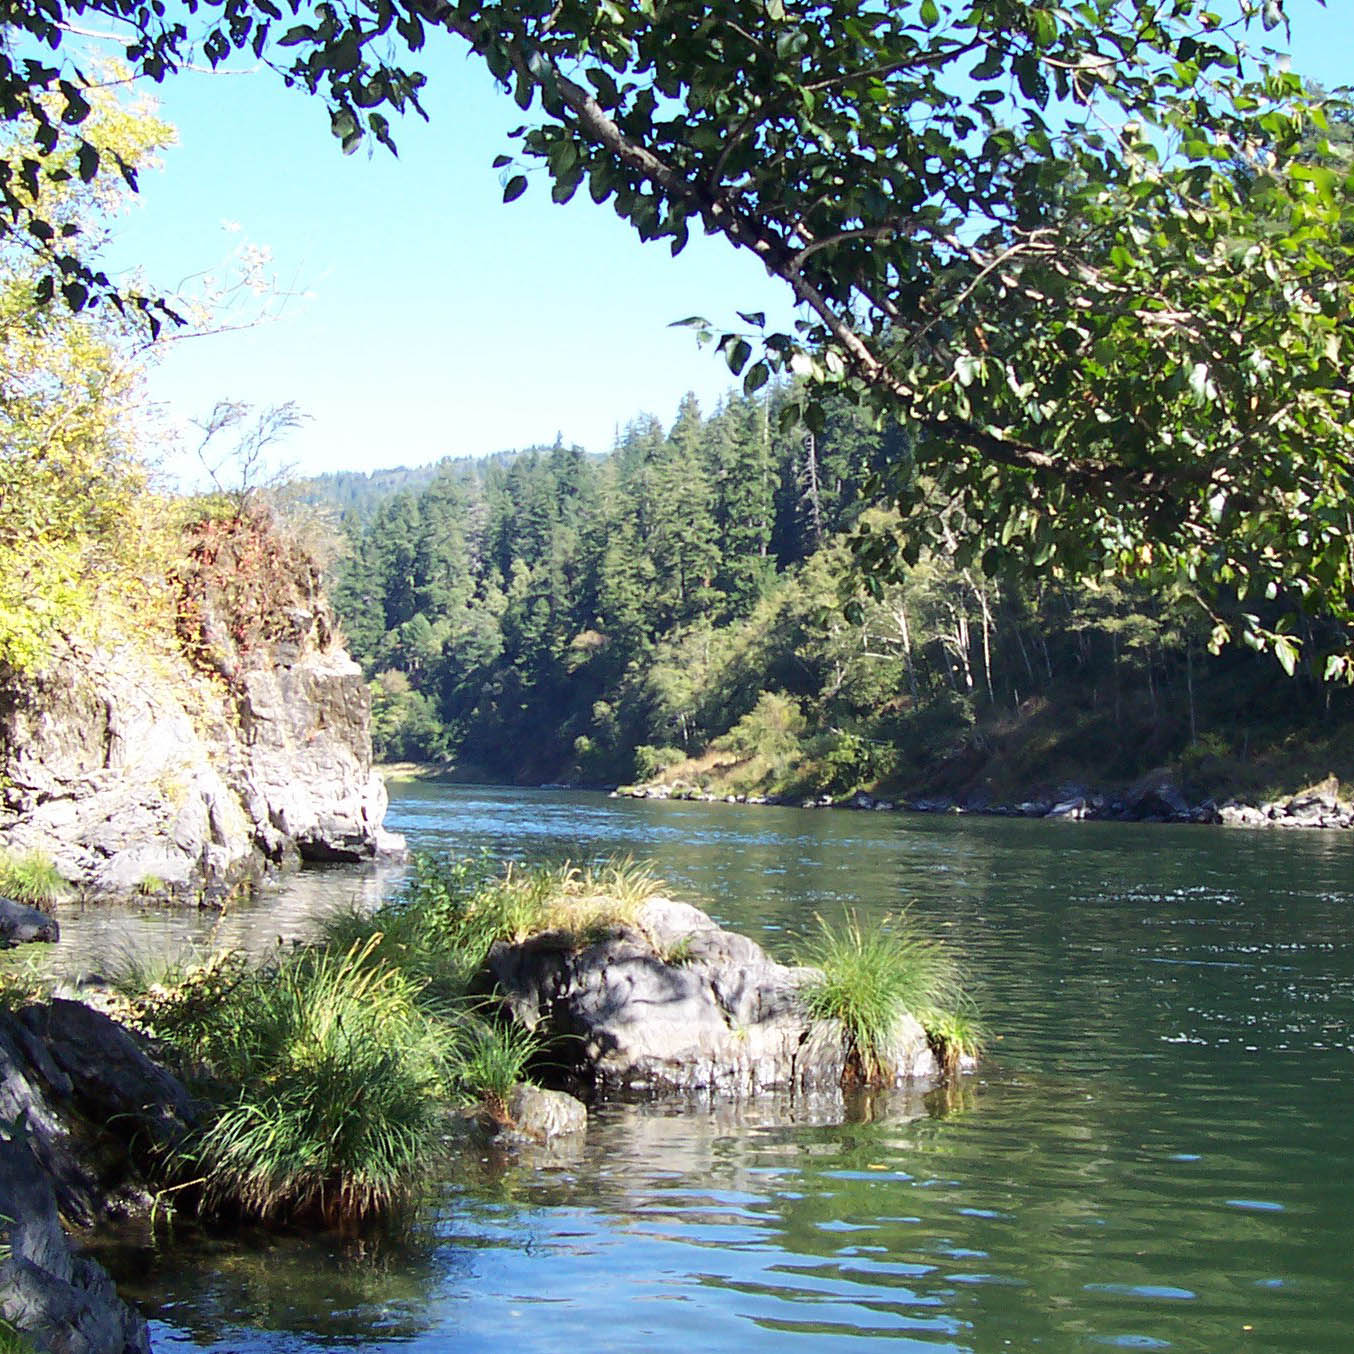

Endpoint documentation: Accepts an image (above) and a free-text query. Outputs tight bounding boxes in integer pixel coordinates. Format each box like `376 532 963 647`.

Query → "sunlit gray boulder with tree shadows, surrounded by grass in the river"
486 899 937 1095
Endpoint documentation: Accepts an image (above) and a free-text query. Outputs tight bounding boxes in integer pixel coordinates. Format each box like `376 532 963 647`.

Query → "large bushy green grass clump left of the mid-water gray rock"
136 942 452 1231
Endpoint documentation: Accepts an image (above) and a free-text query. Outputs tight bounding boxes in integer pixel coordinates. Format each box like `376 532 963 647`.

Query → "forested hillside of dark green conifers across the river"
334 387 1350 800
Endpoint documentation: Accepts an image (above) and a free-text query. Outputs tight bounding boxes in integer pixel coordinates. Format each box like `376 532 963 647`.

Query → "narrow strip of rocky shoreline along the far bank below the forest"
611 774 1354 829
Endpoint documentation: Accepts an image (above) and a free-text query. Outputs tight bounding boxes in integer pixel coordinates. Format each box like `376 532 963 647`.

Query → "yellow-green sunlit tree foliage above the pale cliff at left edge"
0 77 169 670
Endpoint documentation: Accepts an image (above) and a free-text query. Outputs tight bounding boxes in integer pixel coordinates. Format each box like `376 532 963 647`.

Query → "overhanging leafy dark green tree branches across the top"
0 0 1354 674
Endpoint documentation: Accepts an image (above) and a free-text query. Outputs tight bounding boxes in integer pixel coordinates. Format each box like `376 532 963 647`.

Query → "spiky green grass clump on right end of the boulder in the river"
803 913 979 1085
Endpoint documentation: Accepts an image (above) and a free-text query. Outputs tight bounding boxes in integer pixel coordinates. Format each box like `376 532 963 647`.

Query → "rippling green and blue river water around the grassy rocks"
68 784 1354 1354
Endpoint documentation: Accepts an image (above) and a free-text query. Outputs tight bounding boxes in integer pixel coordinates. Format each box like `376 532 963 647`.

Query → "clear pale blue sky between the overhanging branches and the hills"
100 0 1354 487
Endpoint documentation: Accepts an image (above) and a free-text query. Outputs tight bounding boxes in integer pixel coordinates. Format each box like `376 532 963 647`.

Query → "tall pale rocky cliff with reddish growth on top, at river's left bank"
0 509 401 900
